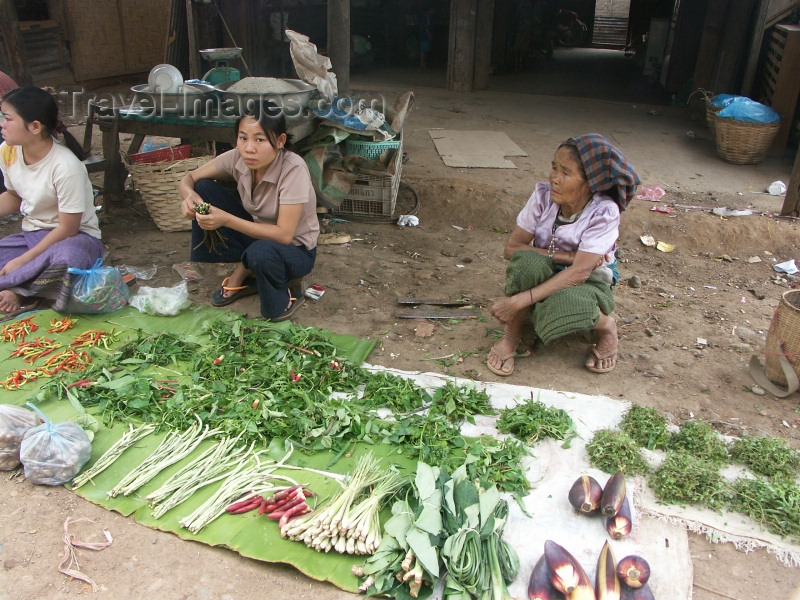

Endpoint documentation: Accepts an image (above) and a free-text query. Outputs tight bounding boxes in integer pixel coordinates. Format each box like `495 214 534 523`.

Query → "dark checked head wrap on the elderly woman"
562 133 641 212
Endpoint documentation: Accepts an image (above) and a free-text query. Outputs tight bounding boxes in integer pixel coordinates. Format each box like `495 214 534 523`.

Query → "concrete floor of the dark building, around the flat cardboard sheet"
350 48 797 206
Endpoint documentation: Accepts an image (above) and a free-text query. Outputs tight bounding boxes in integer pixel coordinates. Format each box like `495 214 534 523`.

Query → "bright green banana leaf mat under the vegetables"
0 306 382 592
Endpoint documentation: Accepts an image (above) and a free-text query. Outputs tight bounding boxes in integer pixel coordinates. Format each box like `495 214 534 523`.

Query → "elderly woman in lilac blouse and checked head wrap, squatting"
486 134 640 376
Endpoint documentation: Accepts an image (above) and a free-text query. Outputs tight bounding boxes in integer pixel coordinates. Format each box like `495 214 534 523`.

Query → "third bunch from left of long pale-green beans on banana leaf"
145 435 253 519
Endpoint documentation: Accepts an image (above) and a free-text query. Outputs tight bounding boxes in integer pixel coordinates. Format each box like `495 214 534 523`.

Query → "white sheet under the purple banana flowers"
365 365 692 600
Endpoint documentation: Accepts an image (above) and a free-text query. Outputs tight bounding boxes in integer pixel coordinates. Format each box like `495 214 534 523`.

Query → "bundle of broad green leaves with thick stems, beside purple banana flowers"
354 462 519 600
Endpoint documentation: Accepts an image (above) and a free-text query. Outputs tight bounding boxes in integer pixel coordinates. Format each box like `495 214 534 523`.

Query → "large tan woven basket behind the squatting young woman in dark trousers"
123 156 213 232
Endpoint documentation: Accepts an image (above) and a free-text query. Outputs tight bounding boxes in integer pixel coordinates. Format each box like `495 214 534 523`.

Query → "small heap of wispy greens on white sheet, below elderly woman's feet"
497 398 576 448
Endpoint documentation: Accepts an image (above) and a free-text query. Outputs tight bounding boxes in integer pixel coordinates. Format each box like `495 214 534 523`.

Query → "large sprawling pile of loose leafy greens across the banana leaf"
32 319 529 495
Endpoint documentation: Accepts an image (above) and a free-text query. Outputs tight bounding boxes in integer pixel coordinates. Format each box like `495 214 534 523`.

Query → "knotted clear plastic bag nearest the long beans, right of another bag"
19 402 92 485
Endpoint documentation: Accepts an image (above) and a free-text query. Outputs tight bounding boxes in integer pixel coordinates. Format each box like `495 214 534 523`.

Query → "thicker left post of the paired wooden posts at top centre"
447 0 478 92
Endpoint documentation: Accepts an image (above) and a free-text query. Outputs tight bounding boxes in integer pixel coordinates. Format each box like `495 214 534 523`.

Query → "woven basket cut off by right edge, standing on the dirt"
764 290 800 387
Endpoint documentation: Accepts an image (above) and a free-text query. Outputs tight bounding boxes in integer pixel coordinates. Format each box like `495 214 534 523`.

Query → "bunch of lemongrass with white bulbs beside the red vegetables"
281 454 406 555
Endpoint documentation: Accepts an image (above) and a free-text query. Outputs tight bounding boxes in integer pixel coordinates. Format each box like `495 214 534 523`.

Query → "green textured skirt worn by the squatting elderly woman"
506 250 615 344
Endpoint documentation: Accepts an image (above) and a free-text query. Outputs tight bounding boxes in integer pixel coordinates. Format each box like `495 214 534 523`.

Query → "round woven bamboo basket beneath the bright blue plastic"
713 114 781 165
